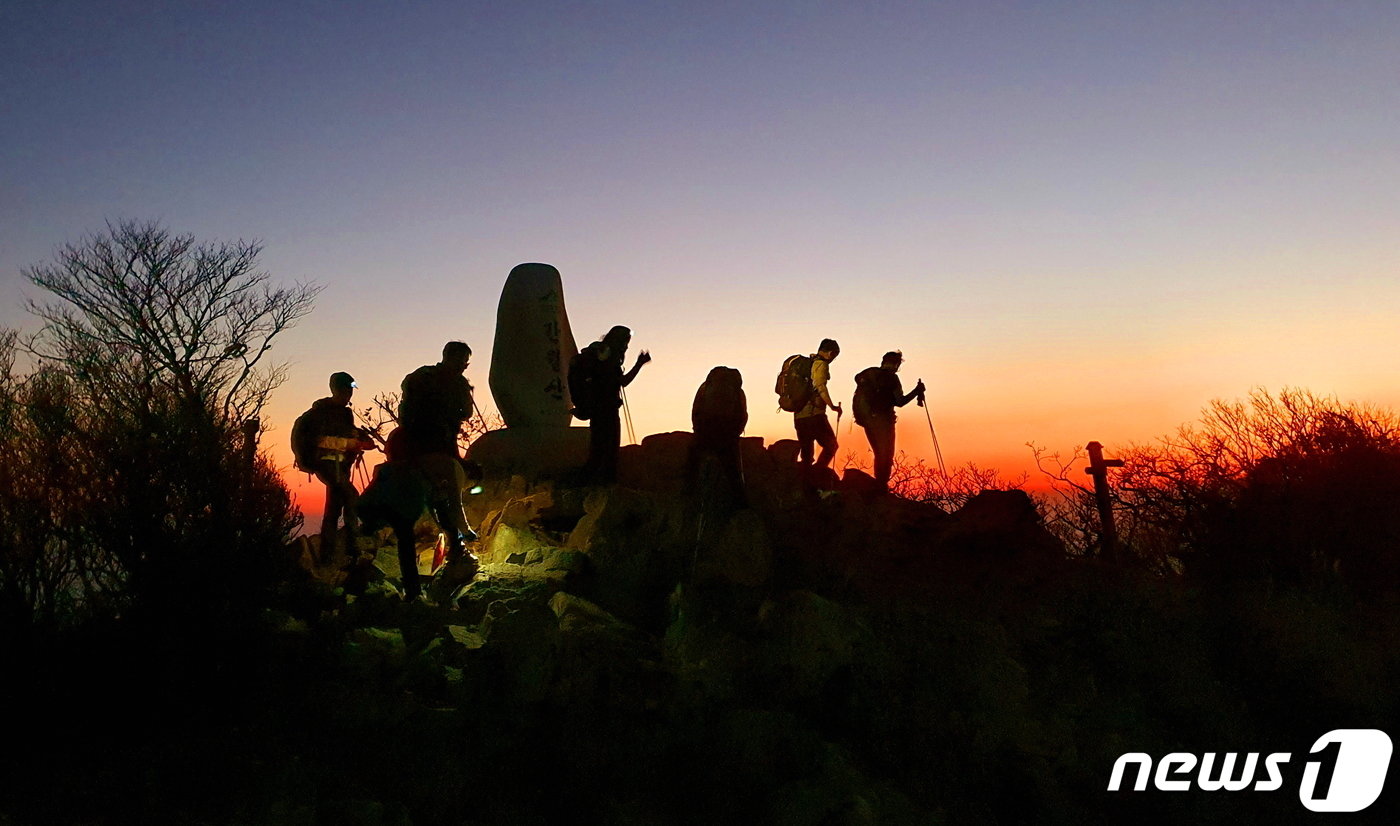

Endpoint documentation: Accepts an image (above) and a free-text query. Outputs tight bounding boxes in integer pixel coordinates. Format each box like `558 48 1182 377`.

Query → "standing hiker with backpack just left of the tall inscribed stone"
399 342 476 581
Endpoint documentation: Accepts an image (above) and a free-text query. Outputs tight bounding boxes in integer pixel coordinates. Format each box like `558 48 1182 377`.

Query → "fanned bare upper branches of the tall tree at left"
24 221 321 424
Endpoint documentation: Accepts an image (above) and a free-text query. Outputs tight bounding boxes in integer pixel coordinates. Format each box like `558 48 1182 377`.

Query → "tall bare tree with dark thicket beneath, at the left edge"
0 221 318 622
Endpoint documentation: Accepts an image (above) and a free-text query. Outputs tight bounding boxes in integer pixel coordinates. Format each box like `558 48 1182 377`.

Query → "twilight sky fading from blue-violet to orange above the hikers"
0 0 1400 512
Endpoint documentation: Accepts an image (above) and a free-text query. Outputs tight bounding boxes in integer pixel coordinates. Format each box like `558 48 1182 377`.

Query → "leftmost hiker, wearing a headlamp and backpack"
291 372 374 563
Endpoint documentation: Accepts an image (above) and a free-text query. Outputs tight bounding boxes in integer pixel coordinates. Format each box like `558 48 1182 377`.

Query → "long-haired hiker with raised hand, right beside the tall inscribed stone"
568 326 651 484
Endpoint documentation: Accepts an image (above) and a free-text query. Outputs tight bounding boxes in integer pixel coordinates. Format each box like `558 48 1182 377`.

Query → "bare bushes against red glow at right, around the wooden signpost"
1032 388 1400 588
